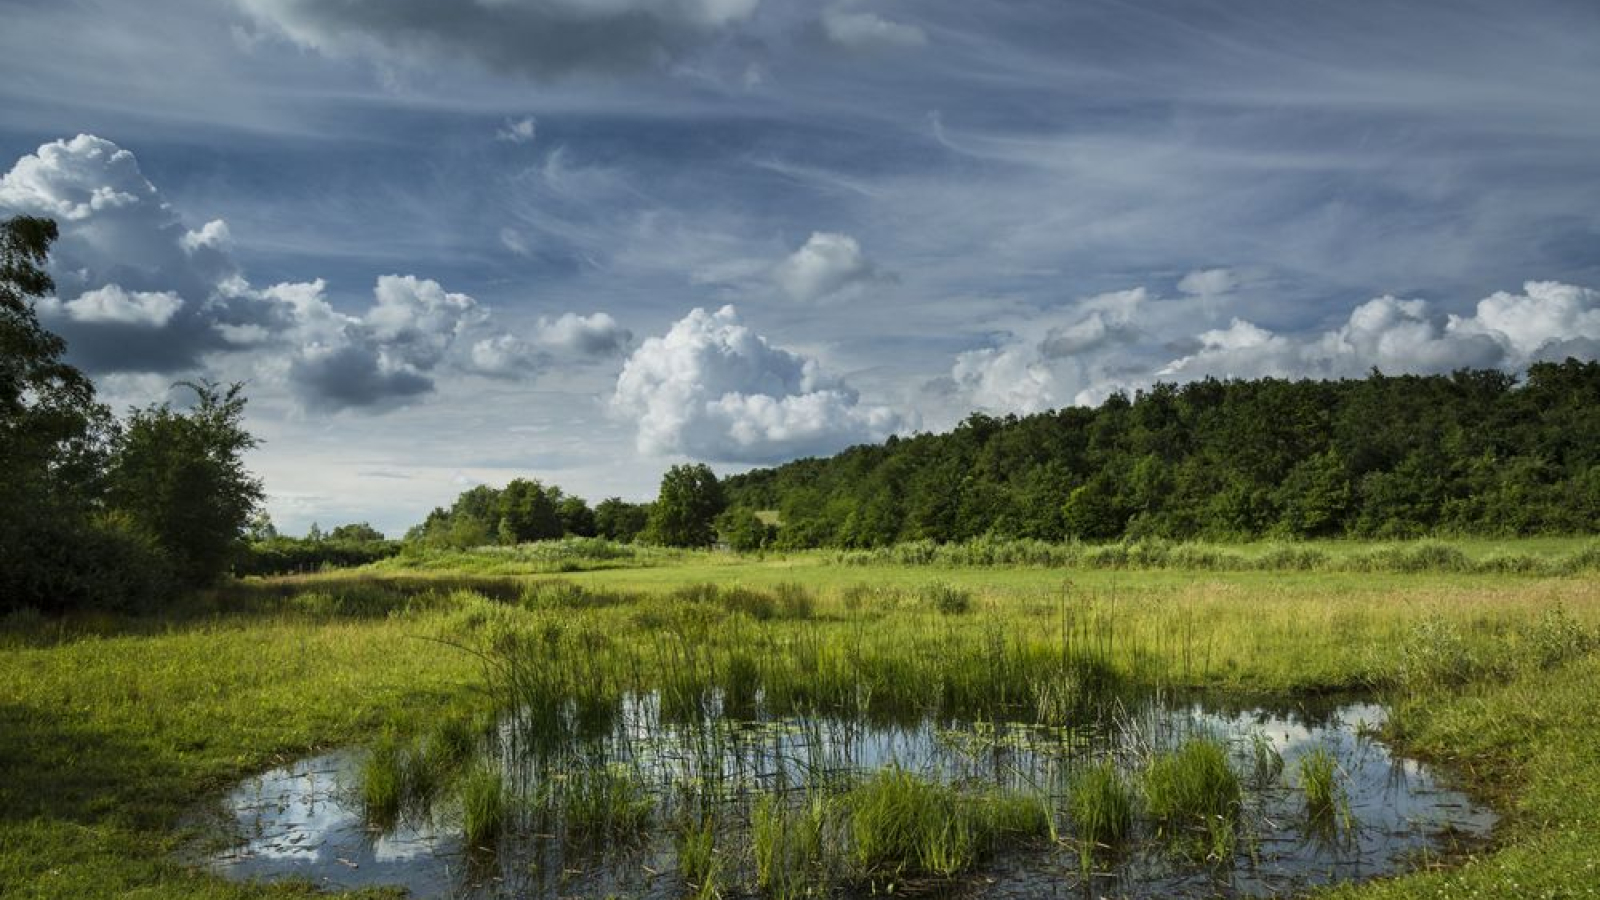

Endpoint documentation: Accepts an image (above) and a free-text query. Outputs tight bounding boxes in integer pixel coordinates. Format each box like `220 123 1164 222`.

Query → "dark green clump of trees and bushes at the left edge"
0 216 261 612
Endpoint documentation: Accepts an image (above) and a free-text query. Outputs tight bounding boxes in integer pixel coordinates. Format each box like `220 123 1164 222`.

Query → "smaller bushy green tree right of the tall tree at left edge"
106 381 262 586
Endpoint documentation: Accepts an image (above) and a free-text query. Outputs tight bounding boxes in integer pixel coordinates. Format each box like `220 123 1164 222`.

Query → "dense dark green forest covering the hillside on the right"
723 359 1600 548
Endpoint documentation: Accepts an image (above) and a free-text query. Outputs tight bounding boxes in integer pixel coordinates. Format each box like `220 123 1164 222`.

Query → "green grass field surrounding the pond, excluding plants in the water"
0 541 1600 897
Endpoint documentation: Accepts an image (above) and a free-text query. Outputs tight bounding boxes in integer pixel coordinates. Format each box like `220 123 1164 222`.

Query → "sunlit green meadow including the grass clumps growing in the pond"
0 540 1600 897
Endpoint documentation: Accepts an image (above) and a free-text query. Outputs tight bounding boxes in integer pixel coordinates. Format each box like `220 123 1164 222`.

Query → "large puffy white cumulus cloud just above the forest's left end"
611 306 902 463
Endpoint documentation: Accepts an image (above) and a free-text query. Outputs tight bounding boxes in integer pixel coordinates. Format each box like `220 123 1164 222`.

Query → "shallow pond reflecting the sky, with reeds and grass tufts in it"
206 695 1494 898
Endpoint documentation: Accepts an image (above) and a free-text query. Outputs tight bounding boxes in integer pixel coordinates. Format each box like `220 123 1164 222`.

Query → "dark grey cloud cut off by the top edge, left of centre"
238 0 758 78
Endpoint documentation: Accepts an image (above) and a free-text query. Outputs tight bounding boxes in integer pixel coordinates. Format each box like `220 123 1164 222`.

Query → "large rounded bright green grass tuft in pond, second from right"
1144 738 1243 860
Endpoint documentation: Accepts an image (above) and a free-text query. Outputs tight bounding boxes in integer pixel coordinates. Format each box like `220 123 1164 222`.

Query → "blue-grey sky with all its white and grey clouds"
0 0 1600 535
